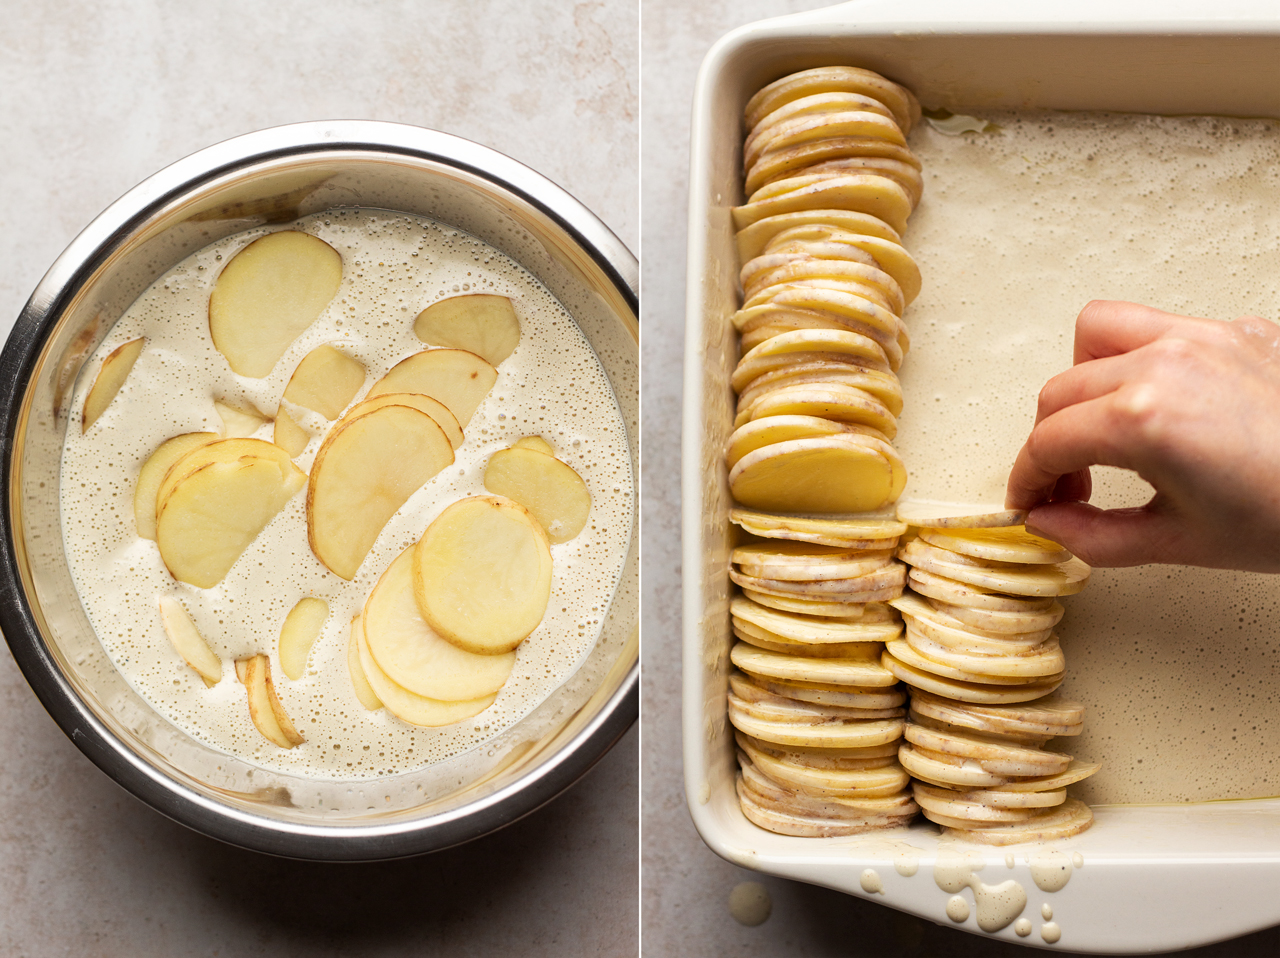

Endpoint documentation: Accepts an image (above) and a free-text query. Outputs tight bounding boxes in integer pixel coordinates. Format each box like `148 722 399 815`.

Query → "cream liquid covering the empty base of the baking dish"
911 113 1280 803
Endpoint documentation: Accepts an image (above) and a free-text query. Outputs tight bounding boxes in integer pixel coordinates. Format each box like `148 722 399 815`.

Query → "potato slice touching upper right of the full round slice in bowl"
484 446 591 543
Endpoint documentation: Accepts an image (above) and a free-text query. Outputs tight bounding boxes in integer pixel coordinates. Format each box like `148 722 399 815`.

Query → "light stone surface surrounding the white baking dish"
641 0 1280 958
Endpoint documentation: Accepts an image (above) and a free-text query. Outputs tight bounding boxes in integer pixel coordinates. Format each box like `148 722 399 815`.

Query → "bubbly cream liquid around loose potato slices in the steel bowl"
61 210 634 780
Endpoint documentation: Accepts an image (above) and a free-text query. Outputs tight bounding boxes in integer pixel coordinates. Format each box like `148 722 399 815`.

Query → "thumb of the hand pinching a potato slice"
1027 502 1178 567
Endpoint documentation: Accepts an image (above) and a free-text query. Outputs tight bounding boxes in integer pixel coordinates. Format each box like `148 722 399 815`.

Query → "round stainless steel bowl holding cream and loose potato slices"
0 122 639 861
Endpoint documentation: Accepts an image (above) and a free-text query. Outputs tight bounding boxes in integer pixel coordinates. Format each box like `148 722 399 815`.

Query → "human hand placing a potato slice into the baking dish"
1006 301 1280 572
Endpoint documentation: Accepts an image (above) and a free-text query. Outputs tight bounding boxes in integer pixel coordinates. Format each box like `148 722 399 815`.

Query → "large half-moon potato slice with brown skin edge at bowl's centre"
307 406 453 580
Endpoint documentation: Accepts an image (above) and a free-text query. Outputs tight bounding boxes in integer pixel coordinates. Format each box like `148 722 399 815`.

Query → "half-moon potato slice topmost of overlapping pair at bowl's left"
156 450 307 589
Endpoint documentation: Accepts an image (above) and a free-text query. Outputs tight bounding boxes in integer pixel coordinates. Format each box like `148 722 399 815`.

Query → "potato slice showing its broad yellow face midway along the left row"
728 435 905 512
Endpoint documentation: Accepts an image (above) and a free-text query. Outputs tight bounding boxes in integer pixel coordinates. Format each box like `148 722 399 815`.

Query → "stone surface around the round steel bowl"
0 0 639 958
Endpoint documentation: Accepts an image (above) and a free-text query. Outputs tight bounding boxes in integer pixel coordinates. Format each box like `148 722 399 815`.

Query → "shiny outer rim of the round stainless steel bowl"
0 120 640 862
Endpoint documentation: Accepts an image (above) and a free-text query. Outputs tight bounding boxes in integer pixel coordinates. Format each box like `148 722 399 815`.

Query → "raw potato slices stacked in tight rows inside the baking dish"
726 67 1097 844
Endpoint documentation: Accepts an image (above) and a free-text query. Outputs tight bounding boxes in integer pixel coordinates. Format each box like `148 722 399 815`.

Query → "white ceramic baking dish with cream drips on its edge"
682 0 1280 953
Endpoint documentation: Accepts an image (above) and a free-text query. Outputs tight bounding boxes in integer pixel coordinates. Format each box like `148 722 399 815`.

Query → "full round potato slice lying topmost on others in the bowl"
412 496 552 655
